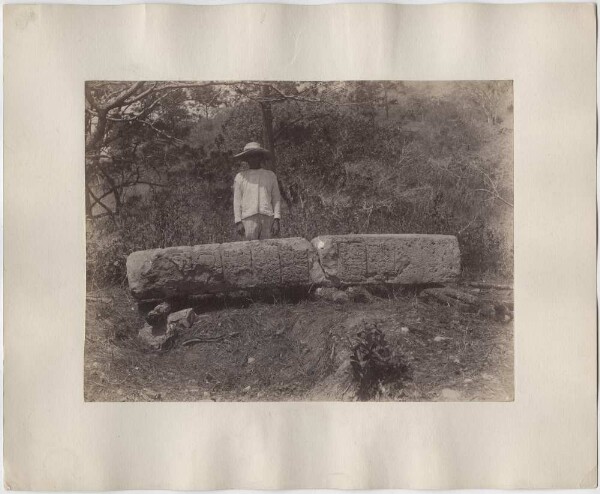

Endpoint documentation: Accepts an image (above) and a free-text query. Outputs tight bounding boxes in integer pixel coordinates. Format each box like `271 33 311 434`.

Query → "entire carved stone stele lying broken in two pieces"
127 234 460 301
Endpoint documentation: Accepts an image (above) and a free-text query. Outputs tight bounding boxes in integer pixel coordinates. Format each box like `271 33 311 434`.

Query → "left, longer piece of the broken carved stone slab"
127 238 324 301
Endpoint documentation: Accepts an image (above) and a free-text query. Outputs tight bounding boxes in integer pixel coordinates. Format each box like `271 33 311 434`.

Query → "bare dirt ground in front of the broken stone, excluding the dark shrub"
84 288 514 401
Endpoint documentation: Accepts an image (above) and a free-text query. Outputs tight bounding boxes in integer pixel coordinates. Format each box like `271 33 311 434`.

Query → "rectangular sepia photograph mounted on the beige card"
83 80 514 402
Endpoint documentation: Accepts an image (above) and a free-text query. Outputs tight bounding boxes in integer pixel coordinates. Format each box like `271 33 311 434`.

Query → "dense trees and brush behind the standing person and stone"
85 81 513 289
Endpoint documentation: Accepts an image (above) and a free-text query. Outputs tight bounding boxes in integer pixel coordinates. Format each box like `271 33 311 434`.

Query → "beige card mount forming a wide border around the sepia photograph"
4 4 596 490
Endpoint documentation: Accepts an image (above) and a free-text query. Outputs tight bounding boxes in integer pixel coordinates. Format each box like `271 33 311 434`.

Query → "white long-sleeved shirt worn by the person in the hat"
233 168 281 223
